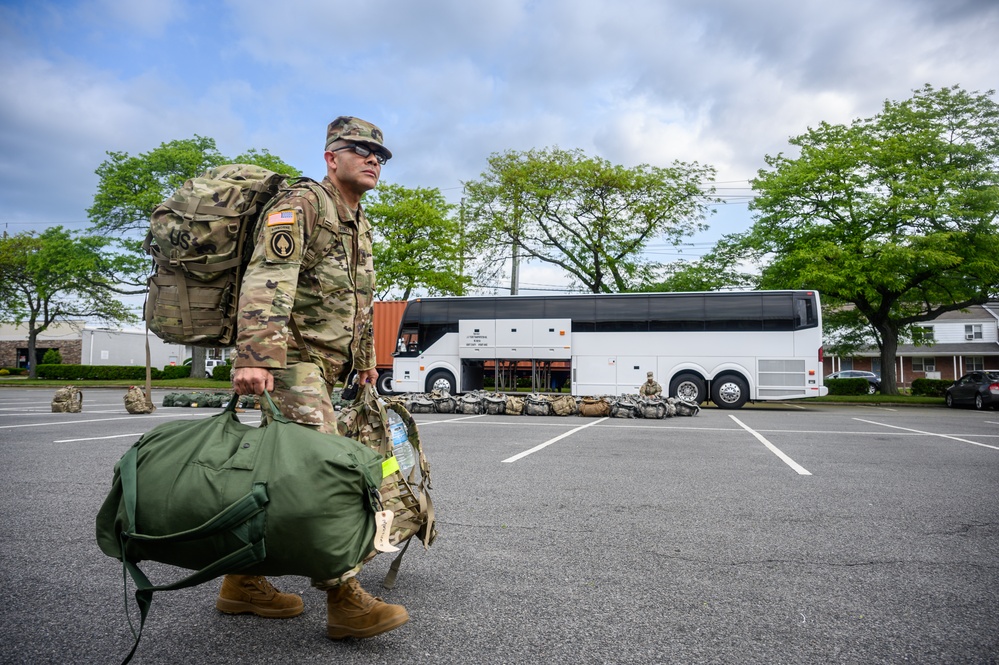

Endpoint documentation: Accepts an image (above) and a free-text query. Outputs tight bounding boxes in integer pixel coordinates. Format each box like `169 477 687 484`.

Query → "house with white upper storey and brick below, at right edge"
823 301 999 388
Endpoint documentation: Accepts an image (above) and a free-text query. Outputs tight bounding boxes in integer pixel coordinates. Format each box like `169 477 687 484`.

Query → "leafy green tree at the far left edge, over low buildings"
0 226 145 378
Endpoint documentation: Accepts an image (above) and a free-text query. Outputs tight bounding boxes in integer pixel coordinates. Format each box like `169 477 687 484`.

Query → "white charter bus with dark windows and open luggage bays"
386 291 828 409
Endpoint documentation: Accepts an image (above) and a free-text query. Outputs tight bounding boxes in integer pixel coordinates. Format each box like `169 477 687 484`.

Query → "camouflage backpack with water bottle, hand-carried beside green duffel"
337 384 437 589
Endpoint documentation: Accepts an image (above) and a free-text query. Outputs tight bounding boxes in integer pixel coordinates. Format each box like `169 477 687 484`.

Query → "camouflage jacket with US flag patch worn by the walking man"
233 178 376 383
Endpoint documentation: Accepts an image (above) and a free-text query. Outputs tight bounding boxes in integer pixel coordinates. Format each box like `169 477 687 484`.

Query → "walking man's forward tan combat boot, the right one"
326 578 409 640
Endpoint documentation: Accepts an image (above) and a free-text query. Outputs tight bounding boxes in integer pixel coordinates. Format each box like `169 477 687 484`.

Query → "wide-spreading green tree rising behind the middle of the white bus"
465 148 714 293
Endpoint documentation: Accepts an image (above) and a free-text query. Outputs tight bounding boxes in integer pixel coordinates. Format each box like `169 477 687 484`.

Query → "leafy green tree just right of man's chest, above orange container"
364 183 471 300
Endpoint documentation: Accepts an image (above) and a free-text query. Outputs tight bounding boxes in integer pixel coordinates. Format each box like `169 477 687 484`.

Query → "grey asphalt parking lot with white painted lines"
0 388 999 665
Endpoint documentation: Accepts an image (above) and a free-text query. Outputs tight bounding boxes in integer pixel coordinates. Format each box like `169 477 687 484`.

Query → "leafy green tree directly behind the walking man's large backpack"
87 135 301 378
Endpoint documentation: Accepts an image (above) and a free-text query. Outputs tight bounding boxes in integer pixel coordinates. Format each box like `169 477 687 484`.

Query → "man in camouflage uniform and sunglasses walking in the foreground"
216 116 409 639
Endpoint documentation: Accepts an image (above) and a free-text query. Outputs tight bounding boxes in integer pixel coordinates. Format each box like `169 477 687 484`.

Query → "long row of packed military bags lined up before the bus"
386 390 701 419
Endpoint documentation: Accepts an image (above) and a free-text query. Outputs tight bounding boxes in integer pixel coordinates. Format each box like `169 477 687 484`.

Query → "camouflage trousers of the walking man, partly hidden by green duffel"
254 363 362 591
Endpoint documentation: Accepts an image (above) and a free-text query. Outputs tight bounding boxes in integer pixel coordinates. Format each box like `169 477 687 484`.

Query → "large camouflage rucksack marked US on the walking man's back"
142 164 335 347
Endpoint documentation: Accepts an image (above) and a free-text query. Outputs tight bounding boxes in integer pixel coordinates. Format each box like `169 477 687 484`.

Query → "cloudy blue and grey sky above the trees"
0 0 999 286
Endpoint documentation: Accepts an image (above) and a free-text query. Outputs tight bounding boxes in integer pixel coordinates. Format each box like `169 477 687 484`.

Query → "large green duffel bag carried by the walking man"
97 393 384 662
